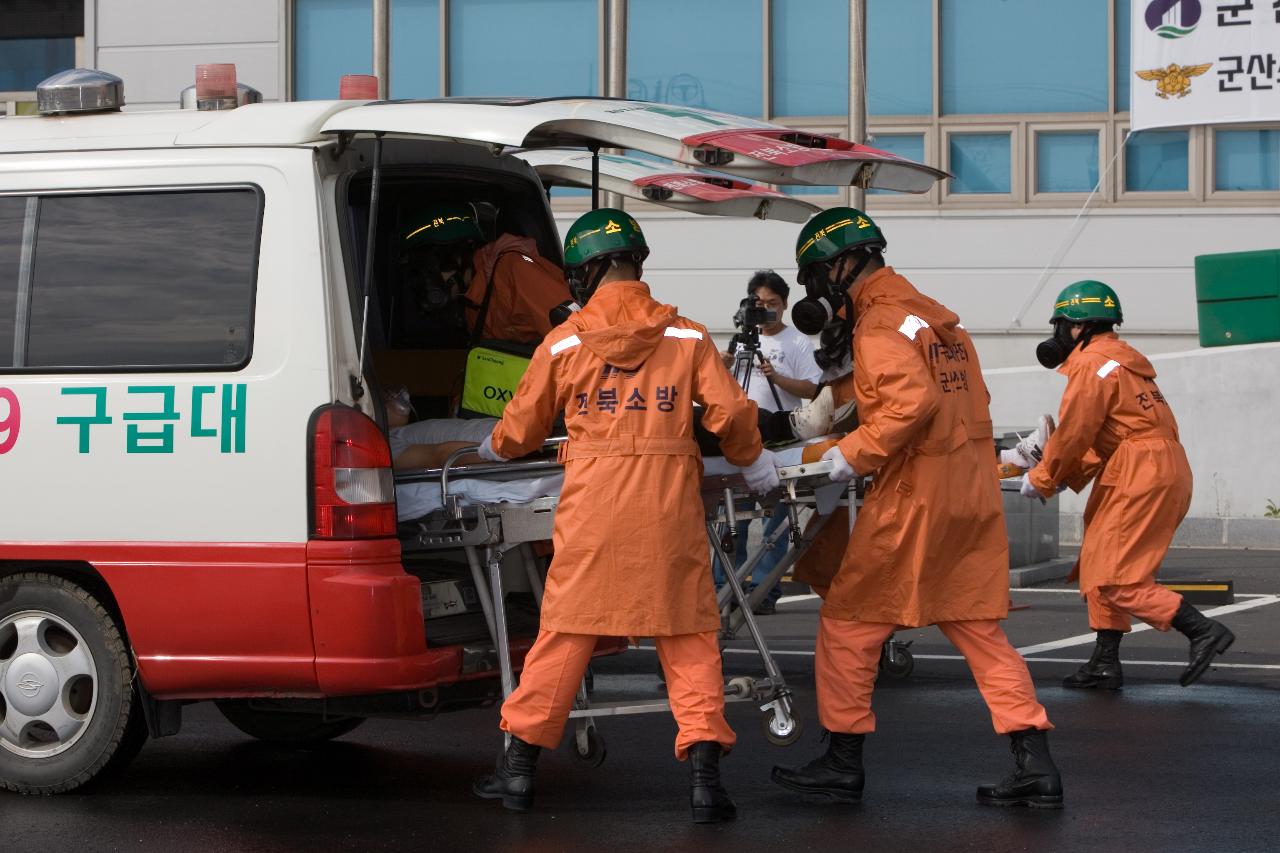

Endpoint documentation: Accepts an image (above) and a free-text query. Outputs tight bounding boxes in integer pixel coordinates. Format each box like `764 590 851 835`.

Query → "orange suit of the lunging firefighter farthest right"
1029 333 1192 631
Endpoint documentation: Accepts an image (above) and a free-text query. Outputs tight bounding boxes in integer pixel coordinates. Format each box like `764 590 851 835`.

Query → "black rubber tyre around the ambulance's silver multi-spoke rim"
0 571 147 795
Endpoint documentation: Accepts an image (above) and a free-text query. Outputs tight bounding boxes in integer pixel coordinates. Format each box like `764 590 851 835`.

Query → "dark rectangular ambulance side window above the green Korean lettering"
21 187 261 369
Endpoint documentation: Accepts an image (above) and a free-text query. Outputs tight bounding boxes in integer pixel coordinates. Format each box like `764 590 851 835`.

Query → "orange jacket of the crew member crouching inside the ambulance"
463 234 572 343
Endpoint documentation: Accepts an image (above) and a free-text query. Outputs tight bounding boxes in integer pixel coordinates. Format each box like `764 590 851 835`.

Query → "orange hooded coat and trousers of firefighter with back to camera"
492 282 763 760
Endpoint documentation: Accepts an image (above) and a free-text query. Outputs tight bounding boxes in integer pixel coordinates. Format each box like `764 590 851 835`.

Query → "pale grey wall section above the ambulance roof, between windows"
84 0 287 110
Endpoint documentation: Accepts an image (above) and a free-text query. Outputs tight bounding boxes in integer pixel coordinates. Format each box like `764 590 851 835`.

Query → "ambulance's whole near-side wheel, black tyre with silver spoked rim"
0 573 147 794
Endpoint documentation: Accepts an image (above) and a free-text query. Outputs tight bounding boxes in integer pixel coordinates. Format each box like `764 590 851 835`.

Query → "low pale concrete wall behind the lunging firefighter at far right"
986 343 1280 548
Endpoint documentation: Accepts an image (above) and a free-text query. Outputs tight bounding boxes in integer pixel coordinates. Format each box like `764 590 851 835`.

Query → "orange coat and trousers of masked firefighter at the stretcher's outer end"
815 266 1052 734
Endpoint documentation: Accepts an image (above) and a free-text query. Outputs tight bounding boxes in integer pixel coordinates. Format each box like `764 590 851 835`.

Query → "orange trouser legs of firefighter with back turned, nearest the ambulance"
502 631 737 761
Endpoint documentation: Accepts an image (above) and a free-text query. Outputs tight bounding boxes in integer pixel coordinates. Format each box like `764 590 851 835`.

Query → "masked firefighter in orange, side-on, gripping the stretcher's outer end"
773 207 1062 808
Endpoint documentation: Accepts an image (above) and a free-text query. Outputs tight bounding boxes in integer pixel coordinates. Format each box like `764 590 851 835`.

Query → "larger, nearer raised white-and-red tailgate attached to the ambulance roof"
314 97 950 192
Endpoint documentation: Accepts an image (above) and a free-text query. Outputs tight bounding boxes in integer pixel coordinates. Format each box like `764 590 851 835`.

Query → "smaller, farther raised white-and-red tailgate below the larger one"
516 149 820 222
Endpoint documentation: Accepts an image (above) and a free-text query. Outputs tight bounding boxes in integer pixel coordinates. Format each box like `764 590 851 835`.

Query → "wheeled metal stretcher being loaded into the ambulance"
396 438 849 763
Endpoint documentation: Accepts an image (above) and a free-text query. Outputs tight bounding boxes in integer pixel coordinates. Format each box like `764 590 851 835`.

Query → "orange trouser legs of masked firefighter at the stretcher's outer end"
814 616 1053 734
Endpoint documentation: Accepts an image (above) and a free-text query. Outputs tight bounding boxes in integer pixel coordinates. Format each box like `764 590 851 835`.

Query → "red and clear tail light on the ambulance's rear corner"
311 405 396 539
